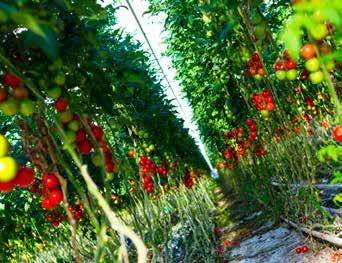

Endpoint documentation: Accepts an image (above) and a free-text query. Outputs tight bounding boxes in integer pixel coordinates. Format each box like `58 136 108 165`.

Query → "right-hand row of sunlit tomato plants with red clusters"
150 0 341 227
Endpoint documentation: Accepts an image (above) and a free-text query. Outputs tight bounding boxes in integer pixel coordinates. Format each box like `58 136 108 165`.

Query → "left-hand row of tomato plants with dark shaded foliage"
0 1 205 262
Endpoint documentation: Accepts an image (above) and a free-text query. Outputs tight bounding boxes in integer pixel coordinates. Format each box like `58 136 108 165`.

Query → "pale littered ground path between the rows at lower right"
216 189 342 263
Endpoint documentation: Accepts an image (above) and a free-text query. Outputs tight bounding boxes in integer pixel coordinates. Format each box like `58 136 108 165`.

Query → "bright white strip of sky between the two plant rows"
98 0 212 173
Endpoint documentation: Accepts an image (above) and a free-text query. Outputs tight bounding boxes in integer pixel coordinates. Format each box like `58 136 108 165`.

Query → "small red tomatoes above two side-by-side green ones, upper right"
273 50 297 80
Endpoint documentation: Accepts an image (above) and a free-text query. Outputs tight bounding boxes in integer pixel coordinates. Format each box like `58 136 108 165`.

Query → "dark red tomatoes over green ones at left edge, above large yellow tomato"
0 71 35 117
